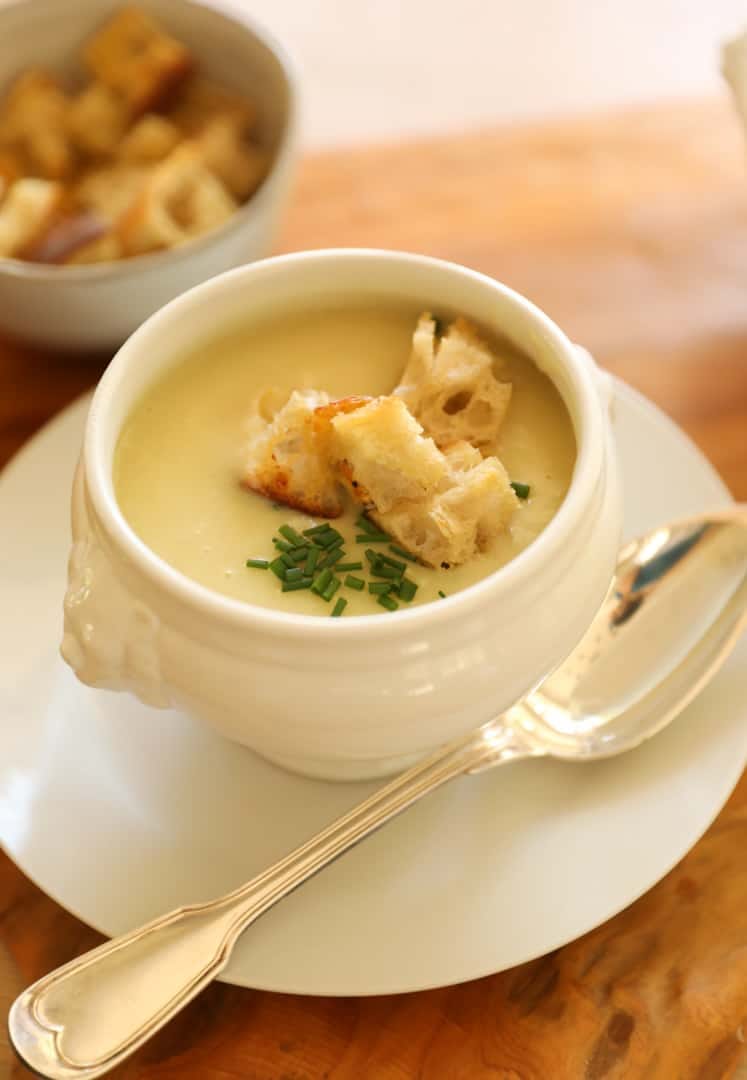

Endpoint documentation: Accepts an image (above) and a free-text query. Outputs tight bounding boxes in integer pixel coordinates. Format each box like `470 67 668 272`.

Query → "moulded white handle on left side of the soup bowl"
60 462 172 708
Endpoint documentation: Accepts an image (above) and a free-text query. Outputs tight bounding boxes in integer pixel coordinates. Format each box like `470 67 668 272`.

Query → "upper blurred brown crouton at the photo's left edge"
0 70 76 180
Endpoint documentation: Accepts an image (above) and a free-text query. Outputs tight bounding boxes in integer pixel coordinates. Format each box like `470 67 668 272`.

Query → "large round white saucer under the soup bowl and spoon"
0 386 747 995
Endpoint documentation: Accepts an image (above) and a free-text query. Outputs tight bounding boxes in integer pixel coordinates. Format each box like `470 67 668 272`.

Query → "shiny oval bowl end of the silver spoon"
503 507 747 760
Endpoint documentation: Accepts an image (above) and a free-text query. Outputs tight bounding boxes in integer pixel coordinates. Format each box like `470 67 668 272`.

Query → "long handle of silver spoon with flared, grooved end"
9 719 532 1080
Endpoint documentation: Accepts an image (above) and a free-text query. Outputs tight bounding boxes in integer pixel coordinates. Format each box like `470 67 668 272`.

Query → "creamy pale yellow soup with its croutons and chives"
114 307 575 617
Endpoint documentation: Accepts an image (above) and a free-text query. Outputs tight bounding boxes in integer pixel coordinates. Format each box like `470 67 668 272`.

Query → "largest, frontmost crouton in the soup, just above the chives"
329 396 518 566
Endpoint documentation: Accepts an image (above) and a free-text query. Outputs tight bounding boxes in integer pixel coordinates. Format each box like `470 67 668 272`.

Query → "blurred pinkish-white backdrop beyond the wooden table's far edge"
246 0 747 148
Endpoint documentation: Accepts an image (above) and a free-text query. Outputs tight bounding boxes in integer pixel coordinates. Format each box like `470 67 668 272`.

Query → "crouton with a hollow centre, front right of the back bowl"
120 144 237 255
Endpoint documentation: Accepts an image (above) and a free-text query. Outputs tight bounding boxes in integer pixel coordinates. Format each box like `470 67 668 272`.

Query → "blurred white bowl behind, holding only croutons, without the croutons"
0 0 297 351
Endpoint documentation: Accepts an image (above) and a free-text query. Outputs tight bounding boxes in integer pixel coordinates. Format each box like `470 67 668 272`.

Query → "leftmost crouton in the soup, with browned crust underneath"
242 390 342 517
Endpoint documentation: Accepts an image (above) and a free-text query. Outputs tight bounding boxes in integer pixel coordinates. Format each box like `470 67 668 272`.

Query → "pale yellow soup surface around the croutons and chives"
114 308 575 616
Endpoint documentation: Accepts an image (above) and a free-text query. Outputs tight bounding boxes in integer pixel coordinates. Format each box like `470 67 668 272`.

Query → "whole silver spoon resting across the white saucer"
9 504 747 1080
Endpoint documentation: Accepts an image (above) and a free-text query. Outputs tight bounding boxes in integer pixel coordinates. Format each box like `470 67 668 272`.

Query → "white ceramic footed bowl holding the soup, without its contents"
63 251 622 779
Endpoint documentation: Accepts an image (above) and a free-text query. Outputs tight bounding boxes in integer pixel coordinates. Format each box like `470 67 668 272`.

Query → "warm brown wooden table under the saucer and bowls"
0 104 747 1080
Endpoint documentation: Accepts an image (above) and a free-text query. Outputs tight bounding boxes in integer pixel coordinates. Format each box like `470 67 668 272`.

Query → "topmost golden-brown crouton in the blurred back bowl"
83 8 193 114
